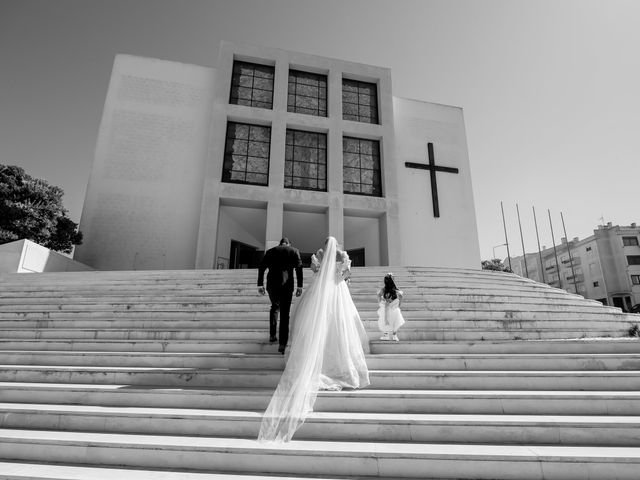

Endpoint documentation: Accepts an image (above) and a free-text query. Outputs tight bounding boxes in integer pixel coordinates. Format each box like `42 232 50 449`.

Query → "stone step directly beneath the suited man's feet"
0 345 640 371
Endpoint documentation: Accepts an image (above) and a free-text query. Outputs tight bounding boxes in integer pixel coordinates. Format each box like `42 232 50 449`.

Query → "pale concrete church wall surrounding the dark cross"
394 98 480 269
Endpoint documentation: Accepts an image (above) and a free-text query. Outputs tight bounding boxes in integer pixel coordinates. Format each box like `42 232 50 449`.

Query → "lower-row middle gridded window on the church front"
284 130 327 192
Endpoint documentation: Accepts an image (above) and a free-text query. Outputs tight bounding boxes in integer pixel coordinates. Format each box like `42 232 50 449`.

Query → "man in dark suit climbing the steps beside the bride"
258 237 302 355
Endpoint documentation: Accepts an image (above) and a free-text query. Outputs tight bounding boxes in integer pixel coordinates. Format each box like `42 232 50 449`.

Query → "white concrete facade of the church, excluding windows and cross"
76 42 480 270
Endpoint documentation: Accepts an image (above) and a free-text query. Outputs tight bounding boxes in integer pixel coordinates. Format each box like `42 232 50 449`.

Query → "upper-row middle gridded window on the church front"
287 70 327 117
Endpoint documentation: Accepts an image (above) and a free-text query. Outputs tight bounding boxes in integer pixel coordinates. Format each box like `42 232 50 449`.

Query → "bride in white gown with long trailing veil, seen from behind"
258 237 369 442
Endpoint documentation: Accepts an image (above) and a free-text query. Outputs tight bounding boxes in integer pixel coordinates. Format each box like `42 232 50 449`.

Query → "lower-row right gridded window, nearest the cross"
342 137 382 197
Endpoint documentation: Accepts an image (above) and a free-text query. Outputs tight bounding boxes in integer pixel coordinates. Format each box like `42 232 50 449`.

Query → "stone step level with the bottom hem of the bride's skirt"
0 365 640 391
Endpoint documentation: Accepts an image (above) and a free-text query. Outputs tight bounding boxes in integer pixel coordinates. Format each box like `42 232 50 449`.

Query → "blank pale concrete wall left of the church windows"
75 55 214 270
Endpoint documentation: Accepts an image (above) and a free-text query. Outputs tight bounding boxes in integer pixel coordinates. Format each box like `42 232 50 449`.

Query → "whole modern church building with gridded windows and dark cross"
75 42 480 270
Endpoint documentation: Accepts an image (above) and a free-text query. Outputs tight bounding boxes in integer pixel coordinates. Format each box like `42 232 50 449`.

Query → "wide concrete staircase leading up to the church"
0 267 640 480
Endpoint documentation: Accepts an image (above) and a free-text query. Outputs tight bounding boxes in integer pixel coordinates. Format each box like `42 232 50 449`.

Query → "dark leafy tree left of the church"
0 165 82 253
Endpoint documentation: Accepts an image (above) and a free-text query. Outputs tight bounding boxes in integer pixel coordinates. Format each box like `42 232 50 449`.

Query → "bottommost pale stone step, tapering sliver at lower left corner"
0 462 340 480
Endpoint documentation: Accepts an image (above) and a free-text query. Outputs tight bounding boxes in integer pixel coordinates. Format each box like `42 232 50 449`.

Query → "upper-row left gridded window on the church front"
229 61 275 109
